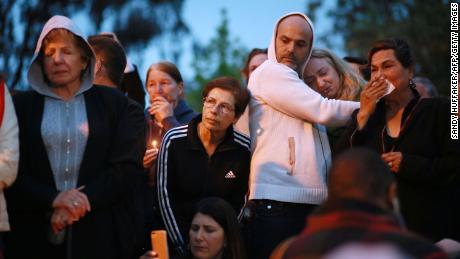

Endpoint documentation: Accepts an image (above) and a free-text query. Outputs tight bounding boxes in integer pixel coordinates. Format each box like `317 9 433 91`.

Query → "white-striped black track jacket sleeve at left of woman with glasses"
157 125 188 254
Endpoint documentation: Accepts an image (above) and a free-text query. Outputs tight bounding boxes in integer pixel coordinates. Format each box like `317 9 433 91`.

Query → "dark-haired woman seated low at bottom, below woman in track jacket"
140 197 246 259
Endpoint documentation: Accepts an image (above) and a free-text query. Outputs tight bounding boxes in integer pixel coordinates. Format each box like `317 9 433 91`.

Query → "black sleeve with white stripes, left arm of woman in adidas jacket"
157 129 186 254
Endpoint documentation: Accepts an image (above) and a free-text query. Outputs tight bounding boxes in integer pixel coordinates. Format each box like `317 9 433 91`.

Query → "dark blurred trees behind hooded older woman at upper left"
0 0 188 91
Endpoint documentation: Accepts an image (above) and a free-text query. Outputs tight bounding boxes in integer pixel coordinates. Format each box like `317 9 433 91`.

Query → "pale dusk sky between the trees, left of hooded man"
140 0 341 80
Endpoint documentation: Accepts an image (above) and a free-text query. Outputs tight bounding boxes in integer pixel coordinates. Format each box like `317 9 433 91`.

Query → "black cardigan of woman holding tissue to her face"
335 95 460 244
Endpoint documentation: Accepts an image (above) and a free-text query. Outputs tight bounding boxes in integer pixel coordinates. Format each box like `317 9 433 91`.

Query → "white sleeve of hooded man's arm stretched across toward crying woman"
255 64 359 126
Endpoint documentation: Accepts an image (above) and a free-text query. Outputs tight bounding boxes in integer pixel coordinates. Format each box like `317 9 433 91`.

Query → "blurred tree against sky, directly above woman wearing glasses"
187 9 247 111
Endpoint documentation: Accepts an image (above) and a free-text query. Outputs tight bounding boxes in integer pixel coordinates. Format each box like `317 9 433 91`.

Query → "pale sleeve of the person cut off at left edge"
0 87 19 189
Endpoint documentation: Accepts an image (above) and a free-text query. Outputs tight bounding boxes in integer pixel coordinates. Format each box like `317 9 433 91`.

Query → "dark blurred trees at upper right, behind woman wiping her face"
307 0 450 95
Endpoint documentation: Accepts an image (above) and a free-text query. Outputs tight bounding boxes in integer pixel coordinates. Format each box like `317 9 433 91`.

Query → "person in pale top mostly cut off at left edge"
0 75 19 258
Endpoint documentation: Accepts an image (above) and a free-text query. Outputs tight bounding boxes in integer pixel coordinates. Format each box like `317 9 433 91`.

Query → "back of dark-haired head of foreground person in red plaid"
328 148 394 203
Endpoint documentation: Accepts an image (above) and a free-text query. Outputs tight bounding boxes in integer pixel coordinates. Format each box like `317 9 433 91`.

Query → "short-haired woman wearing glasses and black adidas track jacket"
157 77 251 254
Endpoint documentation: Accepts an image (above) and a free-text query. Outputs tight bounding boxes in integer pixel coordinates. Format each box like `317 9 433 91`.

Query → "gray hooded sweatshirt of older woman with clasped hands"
27 15 96 191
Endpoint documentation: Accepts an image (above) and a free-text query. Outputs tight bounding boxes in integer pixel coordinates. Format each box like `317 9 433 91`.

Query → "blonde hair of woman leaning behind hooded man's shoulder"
310 48 366 101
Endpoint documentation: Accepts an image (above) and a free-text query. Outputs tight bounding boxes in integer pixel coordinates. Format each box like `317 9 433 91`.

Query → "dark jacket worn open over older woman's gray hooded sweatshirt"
6 86 145 258
